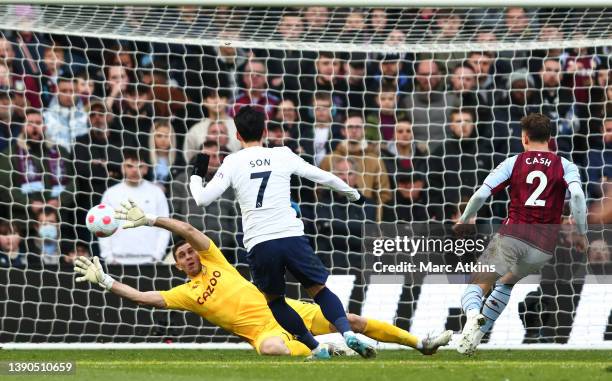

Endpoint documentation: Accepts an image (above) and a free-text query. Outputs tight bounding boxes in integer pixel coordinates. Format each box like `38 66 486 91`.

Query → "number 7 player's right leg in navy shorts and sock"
287 236 376 358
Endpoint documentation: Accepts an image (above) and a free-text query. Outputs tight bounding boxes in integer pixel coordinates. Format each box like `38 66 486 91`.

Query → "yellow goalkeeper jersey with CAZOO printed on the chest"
160 240 274 343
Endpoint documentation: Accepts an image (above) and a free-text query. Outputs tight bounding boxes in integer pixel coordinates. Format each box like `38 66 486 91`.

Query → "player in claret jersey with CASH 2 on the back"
455 114 588 355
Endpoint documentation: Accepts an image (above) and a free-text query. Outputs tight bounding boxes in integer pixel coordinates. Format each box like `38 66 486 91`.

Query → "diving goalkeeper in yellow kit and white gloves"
74 200 452 356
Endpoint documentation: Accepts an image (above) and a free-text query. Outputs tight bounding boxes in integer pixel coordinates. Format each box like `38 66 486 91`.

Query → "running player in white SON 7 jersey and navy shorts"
189 106 376 359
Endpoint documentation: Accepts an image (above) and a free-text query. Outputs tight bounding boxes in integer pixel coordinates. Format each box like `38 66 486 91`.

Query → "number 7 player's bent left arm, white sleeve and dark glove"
189 153 230 207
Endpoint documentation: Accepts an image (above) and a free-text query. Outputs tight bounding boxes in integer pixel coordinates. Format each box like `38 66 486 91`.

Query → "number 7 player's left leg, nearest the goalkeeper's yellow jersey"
247 240 329 358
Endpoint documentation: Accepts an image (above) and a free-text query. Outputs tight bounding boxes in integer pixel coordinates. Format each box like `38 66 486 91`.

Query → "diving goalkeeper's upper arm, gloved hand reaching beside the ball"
115 200 210 251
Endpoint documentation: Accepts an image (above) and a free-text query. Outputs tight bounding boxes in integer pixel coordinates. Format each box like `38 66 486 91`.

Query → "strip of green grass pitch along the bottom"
0 349 612 381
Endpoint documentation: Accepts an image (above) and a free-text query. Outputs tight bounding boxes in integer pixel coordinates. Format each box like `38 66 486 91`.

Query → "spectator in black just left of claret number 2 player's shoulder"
428 109 492 221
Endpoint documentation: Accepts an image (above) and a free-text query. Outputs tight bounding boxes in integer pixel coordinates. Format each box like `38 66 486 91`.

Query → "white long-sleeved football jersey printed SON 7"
192 146 359 251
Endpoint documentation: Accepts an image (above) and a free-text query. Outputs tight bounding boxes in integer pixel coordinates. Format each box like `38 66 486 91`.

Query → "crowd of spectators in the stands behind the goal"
0 7 612 266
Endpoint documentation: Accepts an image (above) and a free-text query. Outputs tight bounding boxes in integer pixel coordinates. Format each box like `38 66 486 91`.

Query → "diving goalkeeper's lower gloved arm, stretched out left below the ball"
74 257 166 308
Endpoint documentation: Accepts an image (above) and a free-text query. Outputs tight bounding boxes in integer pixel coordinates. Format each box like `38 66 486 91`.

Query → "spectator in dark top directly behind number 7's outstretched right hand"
305 156 376 268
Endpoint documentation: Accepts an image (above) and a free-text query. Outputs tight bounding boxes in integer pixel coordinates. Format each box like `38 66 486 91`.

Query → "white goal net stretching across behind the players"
0 4 612 348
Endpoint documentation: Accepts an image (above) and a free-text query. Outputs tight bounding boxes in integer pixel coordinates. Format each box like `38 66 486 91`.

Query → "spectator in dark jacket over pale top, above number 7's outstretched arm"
296 92 341 166
